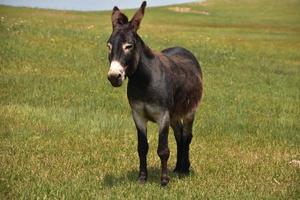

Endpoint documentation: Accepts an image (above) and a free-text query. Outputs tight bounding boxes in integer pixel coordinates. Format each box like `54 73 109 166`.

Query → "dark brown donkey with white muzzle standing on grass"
107 1 203 186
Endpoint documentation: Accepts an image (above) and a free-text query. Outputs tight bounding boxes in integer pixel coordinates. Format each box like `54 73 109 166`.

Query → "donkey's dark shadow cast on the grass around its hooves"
102 167 195 187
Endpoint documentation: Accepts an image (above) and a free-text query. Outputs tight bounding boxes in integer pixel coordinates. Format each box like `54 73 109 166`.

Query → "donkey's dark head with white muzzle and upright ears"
107 1 146 87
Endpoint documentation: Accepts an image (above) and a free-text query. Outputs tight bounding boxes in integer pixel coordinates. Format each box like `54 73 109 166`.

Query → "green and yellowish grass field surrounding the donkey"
0 0 300 199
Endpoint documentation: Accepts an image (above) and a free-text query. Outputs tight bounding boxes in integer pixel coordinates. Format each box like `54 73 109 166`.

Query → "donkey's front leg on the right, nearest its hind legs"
157 112 170 186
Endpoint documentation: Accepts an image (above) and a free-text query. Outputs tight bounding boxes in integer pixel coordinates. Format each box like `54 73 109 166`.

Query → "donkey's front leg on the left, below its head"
132 111 149 183
